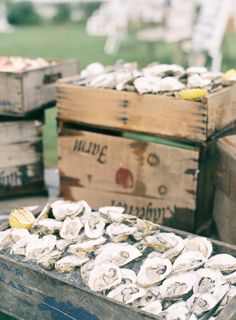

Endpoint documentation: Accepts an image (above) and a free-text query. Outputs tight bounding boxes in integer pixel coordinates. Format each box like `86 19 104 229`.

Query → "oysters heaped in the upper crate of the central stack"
72 62 236 96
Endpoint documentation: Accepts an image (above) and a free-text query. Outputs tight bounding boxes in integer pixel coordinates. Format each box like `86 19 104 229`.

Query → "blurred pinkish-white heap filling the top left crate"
0 57 56 72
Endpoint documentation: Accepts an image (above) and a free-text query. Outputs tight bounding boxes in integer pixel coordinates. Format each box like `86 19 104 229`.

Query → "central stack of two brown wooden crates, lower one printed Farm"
57 78 236 232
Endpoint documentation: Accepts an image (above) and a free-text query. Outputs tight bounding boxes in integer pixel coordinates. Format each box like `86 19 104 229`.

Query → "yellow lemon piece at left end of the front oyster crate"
9 208 35 229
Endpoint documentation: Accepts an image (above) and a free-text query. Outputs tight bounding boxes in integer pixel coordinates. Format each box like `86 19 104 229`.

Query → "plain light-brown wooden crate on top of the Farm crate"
57 77 236 143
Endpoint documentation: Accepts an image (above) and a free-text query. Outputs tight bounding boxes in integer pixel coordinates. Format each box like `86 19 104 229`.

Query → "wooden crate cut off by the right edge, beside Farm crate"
213 135 236 244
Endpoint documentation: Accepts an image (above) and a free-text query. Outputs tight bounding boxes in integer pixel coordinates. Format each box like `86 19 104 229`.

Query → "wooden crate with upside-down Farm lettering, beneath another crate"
59 123 213 232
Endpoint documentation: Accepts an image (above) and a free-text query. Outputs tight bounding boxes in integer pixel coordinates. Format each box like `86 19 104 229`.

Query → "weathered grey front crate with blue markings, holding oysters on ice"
0 220 236 320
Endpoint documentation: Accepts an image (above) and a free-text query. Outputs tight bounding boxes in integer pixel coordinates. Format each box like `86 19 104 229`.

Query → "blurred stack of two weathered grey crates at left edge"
0 57 77 198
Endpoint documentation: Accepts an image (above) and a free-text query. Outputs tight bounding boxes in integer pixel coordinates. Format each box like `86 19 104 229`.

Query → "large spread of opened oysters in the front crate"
0 200 236 320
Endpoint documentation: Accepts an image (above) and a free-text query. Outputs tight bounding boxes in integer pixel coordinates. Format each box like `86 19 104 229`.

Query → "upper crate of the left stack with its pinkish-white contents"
0 56 78 116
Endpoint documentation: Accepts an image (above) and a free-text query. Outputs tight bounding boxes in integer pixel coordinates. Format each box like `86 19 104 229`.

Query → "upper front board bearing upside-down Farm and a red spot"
58 131 199 209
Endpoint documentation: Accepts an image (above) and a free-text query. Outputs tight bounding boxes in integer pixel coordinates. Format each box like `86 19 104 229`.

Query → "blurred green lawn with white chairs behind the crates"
0 0 236 166
